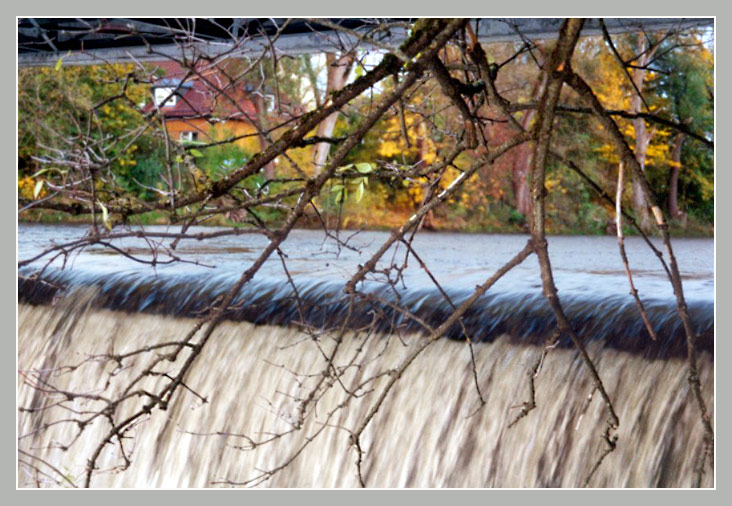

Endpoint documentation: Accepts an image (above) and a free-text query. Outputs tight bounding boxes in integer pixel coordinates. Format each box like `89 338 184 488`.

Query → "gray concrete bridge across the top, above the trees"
18 18 714 67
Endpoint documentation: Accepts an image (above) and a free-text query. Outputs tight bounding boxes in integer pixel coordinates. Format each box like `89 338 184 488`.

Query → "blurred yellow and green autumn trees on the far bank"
18 25 714 235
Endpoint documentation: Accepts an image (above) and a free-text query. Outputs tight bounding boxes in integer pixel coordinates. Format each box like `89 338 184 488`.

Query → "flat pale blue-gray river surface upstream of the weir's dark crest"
18 224 714 301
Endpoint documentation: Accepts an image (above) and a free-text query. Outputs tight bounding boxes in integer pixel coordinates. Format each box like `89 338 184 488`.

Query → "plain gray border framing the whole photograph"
0 0 732 506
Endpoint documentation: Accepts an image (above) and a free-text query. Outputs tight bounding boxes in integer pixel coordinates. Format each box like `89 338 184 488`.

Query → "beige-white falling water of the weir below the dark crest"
18 294 714 487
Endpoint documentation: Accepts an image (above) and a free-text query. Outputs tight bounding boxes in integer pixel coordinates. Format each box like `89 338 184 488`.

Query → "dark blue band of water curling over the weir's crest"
18 269 714 358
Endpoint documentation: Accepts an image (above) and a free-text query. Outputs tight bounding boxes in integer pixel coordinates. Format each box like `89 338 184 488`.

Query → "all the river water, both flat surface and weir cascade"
18 225 714 487
